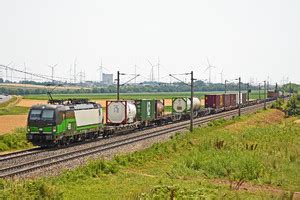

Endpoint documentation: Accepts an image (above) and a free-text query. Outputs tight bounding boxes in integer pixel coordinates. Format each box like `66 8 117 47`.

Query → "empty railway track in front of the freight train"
0 102 270 178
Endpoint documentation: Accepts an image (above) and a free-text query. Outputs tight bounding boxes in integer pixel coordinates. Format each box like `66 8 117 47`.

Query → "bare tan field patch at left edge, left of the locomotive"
0 115 27 135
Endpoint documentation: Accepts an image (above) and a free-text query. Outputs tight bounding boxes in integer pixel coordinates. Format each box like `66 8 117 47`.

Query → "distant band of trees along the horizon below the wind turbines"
0 80 258 95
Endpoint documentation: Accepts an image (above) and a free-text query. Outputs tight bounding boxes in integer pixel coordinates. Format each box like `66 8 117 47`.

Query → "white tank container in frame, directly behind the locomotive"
106 101 136 124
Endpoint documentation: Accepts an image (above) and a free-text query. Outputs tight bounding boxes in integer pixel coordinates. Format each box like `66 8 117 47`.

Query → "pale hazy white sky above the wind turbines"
0 0 300 84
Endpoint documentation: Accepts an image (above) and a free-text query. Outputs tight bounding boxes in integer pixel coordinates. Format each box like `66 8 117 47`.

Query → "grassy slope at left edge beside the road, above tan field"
0 96 29 115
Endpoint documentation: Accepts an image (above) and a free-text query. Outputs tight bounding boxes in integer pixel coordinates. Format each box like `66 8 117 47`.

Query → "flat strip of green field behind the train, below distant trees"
24 91 263 100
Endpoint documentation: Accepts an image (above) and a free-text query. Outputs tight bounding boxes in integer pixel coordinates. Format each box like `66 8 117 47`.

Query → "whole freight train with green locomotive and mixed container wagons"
27 93 282 147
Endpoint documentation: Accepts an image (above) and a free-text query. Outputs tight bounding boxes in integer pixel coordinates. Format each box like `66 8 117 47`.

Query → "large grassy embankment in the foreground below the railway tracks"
0 110 300 199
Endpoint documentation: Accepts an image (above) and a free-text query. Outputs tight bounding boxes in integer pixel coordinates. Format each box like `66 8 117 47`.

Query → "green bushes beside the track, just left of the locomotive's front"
0 128 32 152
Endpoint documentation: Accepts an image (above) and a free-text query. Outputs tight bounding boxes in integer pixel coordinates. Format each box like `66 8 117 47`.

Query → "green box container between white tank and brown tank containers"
136 99 155 121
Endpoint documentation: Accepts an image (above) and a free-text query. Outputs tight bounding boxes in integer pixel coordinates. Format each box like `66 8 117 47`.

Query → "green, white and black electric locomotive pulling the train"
27 99 103 147
